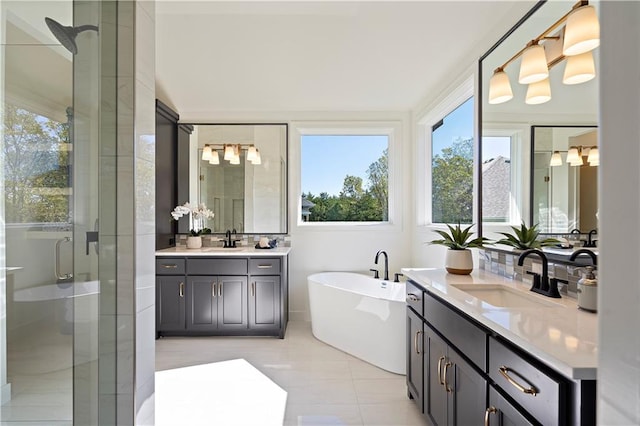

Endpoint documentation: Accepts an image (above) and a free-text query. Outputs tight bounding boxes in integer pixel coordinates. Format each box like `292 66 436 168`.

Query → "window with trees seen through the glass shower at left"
1 104 71 223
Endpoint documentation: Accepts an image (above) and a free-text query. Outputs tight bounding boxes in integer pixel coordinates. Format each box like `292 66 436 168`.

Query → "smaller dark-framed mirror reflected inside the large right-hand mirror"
531 125 599 234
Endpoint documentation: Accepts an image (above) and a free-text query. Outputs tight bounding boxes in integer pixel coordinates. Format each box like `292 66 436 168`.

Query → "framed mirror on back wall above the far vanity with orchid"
189 123 288 235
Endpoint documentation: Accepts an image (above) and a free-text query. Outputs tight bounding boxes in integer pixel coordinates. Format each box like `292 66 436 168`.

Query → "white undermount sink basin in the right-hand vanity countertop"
451 284 558 308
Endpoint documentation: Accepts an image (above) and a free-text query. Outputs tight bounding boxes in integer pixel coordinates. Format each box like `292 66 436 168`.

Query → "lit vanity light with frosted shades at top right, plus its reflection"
489 0 600 105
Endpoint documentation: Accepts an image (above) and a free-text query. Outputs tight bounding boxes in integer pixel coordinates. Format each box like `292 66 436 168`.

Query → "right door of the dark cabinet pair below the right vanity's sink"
445 348 487 425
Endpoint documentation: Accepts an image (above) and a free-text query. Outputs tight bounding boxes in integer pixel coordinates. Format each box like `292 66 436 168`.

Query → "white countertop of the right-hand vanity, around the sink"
402 268 598 380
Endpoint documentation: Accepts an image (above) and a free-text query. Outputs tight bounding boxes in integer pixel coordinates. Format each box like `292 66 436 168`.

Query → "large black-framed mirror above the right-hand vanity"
477 1 599 235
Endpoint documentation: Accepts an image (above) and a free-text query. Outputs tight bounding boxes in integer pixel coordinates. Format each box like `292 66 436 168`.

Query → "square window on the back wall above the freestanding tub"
300 131 390 223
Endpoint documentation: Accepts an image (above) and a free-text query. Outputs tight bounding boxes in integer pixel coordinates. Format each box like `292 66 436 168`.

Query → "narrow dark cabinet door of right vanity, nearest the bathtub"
406 308 425 412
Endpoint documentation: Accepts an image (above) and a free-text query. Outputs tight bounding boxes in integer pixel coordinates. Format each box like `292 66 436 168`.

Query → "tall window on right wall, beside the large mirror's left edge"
431 98 474 223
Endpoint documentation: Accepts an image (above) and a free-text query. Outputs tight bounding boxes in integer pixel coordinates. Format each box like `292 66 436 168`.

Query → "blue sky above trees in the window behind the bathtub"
302 135 389 195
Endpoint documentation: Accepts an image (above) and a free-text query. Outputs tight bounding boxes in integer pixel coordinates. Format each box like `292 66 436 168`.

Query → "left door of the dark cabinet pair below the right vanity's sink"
424 325 451 425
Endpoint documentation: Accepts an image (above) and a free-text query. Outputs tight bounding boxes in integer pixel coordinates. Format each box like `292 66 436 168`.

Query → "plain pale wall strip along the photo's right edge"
598 1 640 425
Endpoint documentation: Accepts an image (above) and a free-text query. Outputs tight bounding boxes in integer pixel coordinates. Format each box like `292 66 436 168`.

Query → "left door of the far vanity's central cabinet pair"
186 276 218 331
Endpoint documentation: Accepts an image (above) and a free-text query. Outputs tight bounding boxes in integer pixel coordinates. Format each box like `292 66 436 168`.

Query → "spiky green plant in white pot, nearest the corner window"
431 223 492 275
